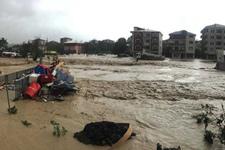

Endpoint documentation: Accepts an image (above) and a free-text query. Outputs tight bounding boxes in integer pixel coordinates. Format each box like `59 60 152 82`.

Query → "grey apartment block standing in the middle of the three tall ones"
167 30 196 58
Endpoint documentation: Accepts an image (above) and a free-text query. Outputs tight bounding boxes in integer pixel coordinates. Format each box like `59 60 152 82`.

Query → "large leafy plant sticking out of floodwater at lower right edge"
193 104 225 144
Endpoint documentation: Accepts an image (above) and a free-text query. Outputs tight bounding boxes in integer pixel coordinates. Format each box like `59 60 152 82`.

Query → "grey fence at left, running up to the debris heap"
0 67 34 100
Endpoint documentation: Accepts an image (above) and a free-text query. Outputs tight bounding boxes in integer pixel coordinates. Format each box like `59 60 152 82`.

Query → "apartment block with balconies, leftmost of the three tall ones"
131 27 162 55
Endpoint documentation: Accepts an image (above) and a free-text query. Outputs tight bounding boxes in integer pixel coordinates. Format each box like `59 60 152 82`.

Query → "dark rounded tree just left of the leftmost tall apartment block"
113 38 128 55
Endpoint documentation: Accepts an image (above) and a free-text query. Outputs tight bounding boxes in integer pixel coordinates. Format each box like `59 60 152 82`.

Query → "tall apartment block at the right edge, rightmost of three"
201 24 225 59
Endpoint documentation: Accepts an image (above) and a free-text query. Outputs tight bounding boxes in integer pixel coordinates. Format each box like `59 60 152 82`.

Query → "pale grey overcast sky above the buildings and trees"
0 0 225 43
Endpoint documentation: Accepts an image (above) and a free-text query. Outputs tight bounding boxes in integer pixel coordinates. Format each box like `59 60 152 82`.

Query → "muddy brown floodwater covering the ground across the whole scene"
0 56 225 150
